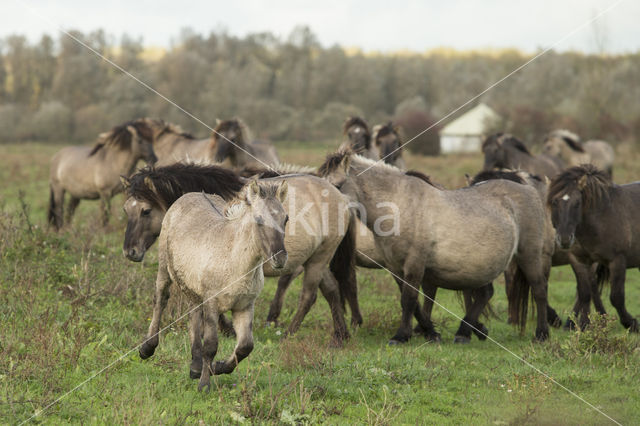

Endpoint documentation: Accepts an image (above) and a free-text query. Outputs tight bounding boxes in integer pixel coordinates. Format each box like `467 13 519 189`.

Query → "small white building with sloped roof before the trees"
440 103 500 154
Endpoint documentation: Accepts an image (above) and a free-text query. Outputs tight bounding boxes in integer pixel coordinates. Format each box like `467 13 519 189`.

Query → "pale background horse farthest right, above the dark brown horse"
543 129 615 176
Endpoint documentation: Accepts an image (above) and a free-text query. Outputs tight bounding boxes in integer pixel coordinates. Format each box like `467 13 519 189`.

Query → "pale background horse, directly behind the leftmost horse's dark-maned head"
143 118 215 166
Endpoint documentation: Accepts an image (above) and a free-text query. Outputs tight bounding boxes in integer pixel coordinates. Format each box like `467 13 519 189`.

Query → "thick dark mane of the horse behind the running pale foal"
127 163 244 209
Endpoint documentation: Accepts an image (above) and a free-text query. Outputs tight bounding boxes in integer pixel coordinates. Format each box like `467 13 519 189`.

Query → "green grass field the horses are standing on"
0 143 640 425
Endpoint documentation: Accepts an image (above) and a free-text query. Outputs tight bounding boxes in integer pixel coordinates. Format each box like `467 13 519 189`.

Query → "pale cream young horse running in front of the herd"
139 181 288 390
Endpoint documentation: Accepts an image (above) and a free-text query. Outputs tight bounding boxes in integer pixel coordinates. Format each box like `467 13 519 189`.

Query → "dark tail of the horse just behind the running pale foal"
329 210 358 315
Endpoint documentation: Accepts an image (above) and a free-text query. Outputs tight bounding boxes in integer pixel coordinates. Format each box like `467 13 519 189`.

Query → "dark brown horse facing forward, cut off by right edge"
547 164 640 332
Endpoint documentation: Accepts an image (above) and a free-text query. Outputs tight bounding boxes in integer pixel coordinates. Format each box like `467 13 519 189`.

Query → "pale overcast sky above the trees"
0 0 640 53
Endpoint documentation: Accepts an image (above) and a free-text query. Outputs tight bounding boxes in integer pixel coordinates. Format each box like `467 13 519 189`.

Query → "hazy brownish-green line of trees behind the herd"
0 27 640 154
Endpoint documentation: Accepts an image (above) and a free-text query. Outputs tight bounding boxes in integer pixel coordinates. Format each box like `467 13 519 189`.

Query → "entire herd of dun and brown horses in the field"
49 112 640 389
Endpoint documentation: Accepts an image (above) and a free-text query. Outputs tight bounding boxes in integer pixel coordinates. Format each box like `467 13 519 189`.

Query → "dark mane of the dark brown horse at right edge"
547 164 613 208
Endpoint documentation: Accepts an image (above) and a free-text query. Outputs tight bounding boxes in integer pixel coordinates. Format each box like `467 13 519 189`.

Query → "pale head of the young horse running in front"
246 180 289 269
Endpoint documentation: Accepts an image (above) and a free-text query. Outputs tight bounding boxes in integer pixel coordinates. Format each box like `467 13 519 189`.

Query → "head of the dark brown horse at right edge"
547 164 611 249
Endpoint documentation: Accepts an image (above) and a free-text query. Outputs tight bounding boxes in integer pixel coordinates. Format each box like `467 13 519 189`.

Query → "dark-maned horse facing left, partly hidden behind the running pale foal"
123 164 362 356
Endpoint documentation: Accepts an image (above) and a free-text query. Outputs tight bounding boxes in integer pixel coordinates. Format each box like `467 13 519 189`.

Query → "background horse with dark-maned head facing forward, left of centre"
210 118 280 168
